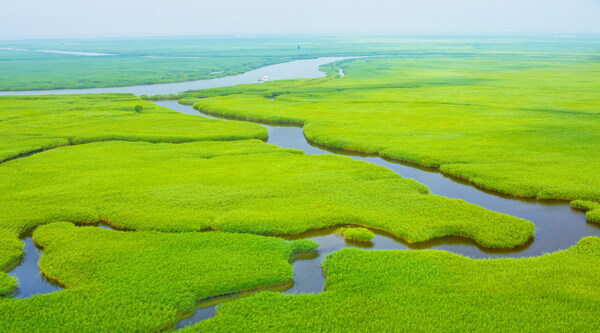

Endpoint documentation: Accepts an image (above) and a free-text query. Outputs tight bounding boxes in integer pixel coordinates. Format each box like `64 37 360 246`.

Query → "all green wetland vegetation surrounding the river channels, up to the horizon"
0 36 600 332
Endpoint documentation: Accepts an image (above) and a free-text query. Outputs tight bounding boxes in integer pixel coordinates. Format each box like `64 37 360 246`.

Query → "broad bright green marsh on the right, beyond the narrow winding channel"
181 55 600 206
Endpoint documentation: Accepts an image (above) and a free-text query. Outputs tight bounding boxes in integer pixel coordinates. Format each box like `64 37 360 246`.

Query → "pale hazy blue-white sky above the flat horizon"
0 0 600 39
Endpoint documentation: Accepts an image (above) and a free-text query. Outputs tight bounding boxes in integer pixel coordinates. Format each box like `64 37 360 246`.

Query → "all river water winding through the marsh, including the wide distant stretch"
0 57 600 328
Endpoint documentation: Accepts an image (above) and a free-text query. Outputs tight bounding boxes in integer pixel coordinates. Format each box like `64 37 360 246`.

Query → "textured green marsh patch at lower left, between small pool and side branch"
0 223 317 332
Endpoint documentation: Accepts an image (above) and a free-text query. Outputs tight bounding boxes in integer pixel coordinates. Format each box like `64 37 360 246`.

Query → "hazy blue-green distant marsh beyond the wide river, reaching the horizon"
0 35 599 91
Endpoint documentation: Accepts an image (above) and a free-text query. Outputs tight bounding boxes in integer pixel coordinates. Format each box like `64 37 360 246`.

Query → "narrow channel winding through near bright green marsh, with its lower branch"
155 94 600 328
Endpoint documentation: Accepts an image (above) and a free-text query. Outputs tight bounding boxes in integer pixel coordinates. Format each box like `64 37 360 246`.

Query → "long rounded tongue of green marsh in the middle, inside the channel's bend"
0 138 534 248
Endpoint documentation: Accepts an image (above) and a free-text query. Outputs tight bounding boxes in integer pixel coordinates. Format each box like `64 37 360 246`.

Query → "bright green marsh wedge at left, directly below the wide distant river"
0 94 268 162
